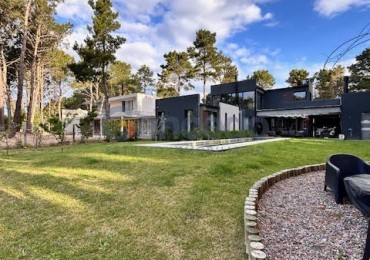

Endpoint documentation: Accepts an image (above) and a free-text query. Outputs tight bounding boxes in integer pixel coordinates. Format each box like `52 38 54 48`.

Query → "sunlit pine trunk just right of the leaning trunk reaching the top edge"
26 24 41 132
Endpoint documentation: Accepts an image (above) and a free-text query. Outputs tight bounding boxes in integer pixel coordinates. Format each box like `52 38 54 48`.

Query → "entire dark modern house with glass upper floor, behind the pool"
155 79 370 139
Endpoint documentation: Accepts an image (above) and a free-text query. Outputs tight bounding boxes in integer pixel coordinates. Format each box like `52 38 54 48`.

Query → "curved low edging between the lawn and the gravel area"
244 163 326 260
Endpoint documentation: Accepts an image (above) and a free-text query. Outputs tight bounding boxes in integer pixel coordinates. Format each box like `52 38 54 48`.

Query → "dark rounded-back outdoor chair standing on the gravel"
324 154 370 204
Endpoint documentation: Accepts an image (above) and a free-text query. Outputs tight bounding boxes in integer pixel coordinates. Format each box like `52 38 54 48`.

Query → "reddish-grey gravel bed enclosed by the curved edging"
258 172 368 260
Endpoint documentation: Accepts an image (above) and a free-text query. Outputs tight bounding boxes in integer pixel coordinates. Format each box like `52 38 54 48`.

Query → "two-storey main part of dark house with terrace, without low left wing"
211 80 370 139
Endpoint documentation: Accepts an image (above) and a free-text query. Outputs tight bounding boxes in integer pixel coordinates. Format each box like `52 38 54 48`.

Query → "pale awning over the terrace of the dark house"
257 106 340 118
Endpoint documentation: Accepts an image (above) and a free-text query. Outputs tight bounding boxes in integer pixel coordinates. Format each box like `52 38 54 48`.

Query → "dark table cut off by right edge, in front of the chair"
344 174 370 260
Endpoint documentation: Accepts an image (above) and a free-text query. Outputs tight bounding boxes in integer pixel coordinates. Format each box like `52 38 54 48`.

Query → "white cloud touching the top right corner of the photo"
314 0 370 17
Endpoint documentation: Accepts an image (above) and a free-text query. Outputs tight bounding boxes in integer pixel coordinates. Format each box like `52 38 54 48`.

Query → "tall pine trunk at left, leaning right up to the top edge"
14 0 33 130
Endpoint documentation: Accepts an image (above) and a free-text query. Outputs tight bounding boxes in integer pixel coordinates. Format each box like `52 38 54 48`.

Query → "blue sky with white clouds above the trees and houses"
57 0 370 94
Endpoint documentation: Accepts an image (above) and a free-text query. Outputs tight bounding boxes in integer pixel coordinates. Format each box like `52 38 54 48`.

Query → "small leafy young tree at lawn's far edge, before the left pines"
40 114 74 152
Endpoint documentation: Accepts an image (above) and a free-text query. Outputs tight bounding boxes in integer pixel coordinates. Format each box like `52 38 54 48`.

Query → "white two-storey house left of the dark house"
94 93 156 139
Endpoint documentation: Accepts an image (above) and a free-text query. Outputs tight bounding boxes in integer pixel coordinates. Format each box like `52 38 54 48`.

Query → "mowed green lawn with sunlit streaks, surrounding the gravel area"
0 139 370 259
